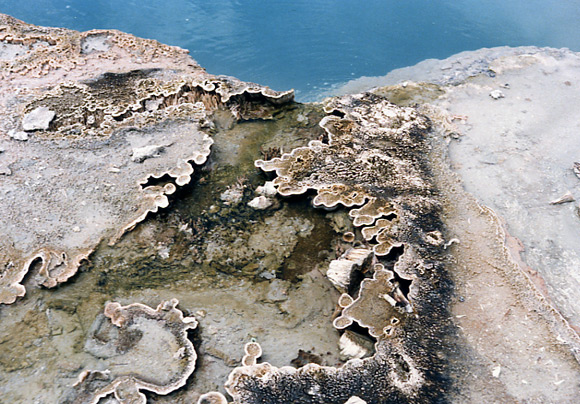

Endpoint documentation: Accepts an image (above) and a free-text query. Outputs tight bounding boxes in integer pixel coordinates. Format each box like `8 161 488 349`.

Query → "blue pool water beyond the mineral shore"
0 0 580 100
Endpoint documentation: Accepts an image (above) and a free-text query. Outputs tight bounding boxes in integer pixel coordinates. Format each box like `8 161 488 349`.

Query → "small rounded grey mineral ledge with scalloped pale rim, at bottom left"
62 299 197 404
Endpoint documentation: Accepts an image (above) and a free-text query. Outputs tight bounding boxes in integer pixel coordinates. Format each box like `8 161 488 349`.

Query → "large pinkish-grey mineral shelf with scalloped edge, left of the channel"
0 15 293 304
